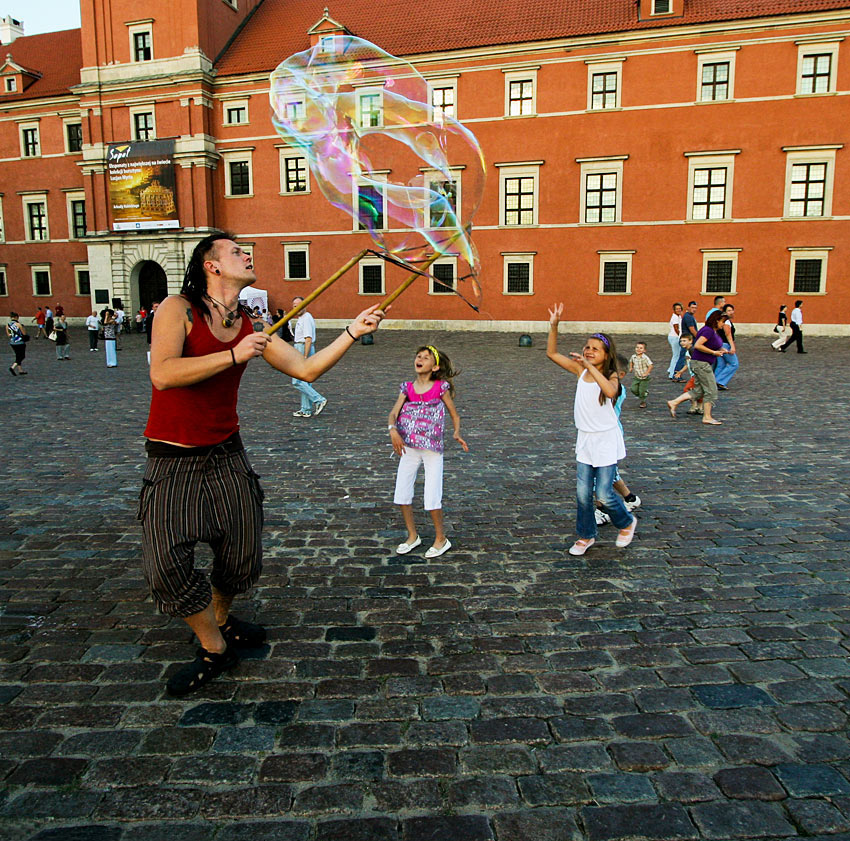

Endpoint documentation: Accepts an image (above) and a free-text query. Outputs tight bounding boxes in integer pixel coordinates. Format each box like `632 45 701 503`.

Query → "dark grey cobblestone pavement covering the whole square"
0 330 850 841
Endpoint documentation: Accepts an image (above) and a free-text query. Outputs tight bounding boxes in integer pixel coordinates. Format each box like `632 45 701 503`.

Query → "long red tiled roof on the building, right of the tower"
216 0 850 76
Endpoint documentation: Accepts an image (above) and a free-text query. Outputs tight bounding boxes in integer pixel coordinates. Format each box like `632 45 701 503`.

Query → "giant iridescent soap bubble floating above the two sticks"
270 35 485 306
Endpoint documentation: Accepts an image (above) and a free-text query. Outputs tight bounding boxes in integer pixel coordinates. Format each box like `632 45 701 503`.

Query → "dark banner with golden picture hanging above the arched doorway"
106 140 180 231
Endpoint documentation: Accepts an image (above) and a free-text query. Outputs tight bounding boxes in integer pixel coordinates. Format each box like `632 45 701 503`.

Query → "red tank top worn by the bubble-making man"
144 306 254 447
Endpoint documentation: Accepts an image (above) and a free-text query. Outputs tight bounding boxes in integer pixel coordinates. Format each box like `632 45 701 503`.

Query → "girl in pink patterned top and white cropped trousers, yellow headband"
388 345 469 558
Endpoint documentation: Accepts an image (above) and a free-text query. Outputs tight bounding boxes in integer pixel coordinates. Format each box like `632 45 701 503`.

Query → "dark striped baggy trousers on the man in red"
138 447 263 616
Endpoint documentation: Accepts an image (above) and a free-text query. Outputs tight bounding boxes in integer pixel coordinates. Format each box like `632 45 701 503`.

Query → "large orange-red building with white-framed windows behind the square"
0 0 850 333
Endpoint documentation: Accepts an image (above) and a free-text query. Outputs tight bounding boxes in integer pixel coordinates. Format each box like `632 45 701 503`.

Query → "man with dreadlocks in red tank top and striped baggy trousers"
138 233 383 695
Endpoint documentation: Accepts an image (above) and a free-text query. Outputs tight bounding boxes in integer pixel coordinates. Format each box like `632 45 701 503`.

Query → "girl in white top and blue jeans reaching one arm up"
546 304 637 555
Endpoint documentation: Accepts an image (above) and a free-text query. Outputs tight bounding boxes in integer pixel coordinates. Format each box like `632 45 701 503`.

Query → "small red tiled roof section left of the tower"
0 29 83 102
